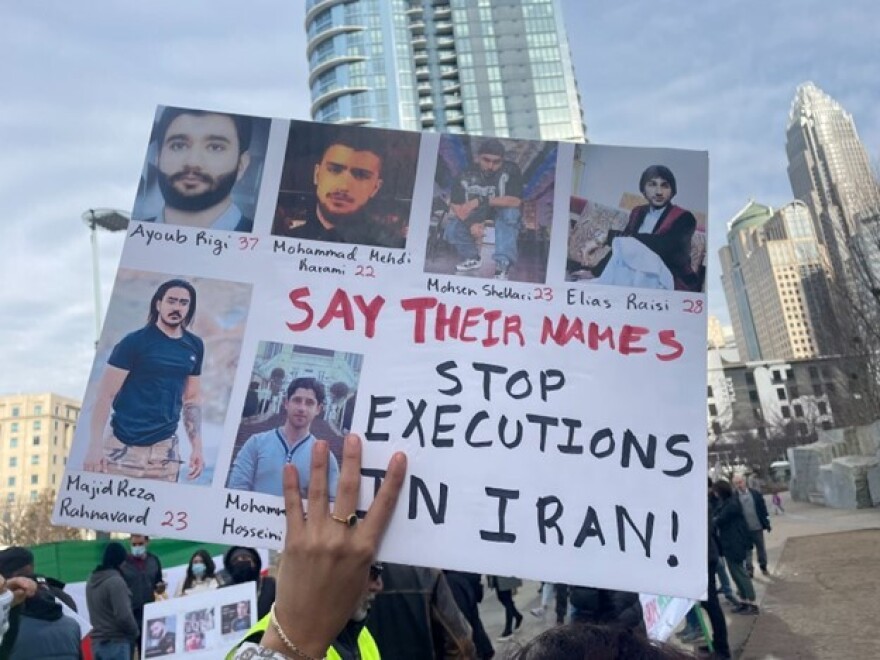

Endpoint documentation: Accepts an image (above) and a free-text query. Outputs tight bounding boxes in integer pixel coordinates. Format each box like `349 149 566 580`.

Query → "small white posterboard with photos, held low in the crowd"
141 582 257 660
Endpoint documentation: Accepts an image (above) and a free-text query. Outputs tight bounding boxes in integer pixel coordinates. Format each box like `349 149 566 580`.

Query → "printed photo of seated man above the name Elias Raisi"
566 145 708 292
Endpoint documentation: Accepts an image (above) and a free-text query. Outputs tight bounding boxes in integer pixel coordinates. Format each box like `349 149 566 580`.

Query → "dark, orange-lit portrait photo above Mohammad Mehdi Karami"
272 121 421 248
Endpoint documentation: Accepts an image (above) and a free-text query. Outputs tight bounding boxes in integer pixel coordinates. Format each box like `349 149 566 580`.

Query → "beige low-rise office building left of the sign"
0 393 82 507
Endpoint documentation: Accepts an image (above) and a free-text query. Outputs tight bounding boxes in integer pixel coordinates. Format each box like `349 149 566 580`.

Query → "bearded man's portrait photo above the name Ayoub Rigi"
132 106 271 232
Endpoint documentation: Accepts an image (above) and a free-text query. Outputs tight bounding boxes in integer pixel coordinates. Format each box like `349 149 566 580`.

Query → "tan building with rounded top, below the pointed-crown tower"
720 200 835 360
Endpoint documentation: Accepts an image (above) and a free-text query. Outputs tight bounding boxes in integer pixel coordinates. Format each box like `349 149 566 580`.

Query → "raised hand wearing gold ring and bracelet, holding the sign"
227 436 406 660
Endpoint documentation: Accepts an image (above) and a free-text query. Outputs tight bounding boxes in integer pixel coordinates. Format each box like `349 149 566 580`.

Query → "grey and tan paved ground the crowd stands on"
480 493 880 660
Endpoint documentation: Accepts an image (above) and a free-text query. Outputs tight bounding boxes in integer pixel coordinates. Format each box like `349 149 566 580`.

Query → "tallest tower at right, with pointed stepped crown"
786 82 880 280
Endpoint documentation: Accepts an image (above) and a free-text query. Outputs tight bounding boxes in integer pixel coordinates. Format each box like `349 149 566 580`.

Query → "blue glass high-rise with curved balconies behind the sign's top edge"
305 0 585 141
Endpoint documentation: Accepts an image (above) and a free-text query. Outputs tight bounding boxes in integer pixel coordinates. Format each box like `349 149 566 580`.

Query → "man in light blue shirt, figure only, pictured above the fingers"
226 378 339 500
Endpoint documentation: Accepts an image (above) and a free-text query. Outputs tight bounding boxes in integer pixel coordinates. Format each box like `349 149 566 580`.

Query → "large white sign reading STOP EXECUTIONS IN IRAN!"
54 108 708 597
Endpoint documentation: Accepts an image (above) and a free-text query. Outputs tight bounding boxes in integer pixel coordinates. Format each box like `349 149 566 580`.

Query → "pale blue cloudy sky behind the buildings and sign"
0 0 880 398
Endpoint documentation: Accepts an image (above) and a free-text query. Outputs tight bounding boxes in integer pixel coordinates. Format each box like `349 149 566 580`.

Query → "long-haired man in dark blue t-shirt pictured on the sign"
83 279 205 482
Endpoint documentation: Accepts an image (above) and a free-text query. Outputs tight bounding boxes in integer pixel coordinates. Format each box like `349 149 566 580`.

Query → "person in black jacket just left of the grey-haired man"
713 481 758 614
